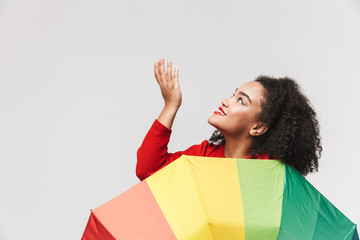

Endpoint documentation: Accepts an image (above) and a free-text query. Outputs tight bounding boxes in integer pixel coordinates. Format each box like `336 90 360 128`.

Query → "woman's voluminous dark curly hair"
209 76 322 176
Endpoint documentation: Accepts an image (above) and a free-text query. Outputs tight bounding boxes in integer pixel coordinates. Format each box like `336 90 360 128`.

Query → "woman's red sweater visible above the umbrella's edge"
136 119 269 181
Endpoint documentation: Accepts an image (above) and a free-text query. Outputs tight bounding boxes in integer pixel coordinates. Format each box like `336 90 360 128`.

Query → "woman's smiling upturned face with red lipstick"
208 82 265 137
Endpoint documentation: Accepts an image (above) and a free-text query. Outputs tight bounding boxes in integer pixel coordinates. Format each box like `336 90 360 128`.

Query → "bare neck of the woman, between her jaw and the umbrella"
224 137 253 158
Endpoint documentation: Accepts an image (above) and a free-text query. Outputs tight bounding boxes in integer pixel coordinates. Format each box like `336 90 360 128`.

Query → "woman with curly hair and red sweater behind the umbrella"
136 58 322 180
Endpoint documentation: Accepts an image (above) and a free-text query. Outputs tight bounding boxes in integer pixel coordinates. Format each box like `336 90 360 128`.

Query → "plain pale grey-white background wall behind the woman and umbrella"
0 0 360 240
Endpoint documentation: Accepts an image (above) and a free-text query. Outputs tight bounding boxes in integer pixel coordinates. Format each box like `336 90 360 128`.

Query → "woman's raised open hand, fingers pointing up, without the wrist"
154 58 182 110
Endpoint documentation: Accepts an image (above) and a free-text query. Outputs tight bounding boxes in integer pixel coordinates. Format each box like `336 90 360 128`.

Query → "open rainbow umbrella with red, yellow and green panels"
82 155 359 240
